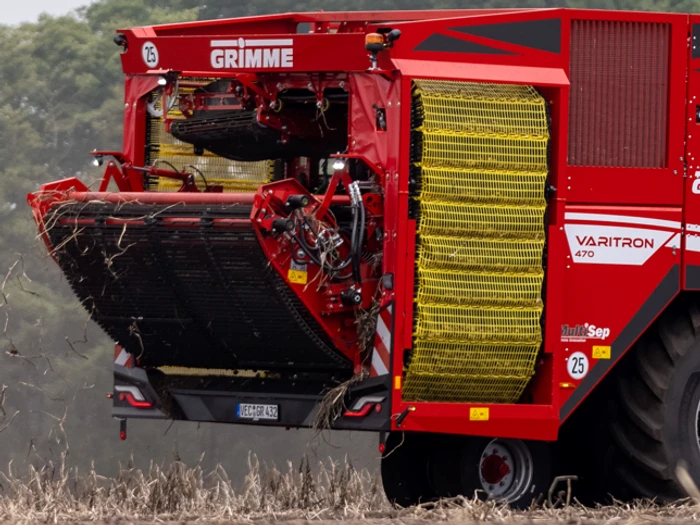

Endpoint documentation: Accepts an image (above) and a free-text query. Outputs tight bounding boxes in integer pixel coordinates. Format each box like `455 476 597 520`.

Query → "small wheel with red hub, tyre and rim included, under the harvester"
462 438 552 508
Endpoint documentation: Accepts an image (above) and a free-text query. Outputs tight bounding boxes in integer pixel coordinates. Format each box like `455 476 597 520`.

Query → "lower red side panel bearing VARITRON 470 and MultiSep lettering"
547 205 682 420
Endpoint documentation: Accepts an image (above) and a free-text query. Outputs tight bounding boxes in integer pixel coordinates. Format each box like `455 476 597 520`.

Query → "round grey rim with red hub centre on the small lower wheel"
479 439 533 502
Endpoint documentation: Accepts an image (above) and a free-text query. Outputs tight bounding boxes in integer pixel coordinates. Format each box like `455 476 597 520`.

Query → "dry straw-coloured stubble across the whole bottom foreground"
0 456 700 525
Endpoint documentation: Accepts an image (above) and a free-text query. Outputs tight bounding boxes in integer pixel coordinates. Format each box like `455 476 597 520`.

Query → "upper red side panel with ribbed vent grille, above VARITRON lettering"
562 11 688 206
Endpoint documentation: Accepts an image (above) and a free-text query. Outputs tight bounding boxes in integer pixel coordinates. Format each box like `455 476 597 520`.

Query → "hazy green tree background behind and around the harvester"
0 0 700 468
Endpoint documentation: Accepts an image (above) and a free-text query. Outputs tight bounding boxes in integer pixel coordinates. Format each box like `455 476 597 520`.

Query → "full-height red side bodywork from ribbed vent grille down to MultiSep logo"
547 11 688 421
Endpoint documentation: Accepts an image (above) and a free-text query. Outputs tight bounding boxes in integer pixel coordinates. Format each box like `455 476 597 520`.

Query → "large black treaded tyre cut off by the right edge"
606 300 700 501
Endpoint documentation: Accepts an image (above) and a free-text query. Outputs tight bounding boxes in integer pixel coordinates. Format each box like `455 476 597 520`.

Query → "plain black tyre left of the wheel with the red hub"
381 432 437 507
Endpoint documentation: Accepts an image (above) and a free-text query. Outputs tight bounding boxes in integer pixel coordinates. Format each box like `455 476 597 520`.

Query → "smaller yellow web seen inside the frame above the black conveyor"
146 79 272 193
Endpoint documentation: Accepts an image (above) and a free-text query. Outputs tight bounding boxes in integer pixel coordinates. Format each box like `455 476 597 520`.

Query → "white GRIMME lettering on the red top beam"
211 38 294 69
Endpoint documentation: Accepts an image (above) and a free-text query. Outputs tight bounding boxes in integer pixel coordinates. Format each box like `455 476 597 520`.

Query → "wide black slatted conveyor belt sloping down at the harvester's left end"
46 199 351 371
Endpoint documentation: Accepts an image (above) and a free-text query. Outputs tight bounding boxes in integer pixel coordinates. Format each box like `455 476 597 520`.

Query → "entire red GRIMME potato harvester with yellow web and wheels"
29 9 700 506
